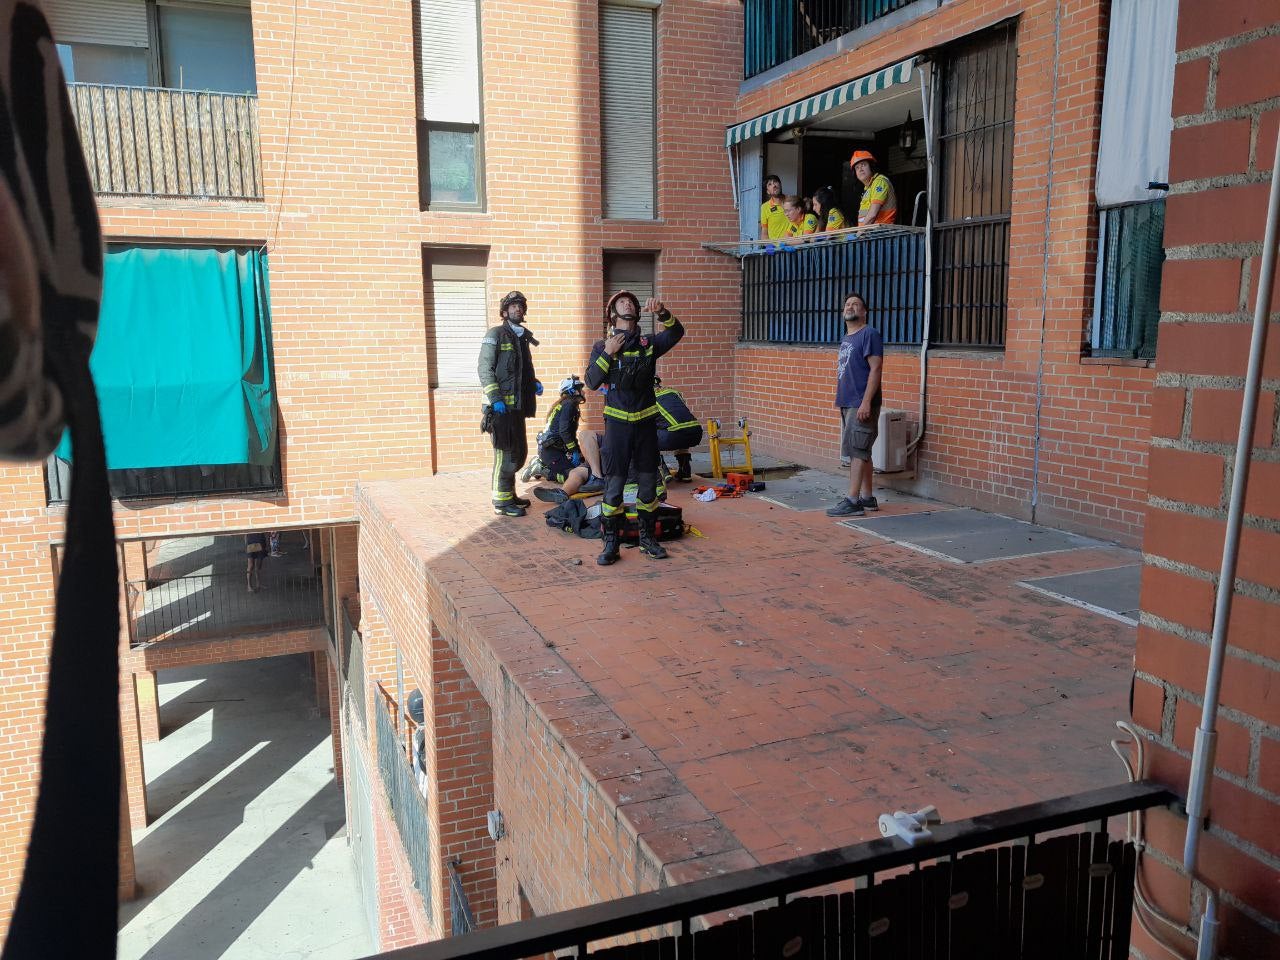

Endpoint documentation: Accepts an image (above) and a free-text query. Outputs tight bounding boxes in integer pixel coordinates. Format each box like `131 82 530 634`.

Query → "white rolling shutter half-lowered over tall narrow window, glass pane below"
417 0 480 125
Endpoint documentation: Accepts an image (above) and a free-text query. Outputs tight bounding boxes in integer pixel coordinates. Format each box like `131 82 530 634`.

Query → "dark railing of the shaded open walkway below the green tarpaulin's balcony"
128 576 324 646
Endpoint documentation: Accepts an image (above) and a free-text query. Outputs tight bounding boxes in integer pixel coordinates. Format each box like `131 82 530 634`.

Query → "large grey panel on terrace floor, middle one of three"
844 509 1108 563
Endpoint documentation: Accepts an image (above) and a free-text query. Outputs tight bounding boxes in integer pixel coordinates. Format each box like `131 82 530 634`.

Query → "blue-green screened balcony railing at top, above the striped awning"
742 0 915 79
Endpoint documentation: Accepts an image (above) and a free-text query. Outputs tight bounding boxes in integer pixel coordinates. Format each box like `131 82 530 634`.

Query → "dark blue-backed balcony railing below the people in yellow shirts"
742 227 924 343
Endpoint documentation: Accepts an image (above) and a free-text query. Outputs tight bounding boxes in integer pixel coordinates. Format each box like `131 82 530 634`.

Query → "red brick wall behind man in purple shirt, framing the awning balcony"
735 0 1164 545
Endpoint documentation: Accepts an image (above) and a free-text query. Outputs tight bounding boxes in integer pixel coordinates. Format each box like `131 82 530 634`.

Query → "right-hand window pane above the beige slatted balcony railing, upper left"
156 4 257 93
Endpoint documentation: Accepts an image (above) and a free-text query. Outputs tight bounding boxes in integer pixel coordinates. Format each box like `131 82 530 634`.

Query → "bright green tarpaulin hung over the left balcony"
58 247 276 470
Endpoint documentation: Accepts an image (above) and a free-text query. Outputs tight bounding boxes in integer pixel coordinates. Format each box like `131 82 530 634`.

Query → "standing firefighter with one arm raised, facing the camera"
586 291 685 566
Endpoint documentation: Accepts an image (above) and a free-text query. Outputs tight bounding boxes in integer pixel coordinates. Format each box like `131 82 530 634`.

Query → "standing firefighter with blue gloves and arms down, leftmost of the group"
477 291 543 517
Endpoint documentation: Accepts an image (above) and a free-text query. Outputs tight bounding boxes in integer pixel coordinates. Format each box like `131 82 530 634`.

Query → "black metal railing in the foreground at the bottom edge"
381 782 1176 960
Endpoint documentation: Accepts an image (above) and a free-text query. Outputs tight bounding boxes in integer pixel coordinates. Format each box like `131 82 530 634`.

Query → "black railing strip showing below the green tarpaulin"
45 454 282 503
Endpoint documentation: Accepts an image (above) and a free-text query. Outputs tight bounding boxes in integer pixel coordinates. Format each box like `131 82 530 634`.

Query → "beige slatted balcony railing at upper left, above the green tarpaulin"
67 83 262 200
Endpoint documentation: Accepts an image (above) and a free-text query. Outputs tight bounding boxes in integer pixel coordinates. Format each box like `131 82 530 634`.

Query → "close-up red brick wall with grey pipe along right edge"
1133 0 1280 959
